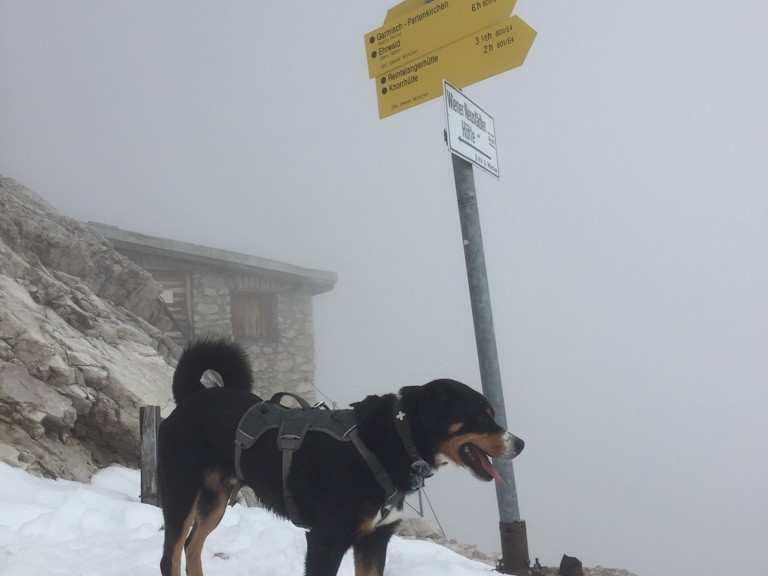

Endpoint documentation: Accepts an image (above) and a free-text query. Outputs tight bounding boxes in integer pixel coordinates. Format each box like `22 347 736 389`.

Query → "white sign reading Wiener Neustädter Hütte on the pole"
443 81 499 178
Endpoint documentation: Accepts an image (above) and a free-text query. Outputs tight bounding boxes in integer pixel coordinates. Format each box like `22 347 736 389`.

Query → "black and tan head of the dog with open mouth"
400 379 525 482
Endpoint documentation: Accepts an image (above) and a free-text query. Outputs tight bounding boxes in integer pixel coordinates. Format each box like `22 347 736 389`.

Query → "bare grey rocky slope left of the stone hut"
0 176 177 480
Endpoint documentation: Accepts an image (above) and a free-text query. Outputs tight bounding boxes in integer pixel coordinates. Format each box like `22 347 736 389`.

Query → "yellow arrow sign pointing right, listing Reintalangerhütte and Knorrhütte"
376 16 536 118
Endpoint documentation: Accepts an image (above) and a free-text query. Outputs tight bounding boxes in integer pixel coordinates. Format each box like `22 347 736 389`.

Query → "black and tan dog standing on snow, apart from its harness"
158 341 523 576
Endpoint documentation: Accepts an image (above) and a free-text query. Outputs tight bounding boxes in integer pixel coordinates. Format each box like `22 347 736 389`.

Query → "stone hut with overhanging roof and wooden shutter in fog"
89 222 336 399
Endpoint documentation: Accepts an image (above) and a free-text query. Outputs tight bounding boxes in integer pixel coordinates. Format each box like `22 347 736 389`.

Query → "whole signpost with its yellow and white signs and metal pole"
363 0 536 575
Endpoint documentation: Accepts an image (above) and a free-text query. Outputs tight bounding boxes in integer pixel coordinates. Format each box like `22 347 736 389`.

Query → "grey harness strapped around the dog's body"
235 392 405 528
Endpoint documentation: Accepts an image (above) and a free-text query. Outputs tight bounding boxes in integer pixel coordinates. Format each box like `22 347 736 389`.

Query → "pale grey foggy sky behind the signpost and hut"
0 0 768 576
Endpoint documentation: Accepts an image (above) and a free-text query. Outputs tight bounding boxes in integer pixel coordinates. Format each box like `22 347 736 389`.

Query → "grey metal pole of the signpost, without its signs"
451 154 530 575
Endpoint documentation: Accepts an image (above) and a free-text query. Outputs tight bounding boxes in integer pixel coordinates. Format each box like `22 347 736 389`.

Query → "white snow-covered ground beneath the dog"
0 463 498 576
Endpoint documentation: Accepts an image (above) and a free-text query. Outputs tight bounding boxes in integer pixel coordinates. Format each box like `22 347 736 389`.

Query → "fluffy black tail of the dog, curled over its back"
172 339 253 404
